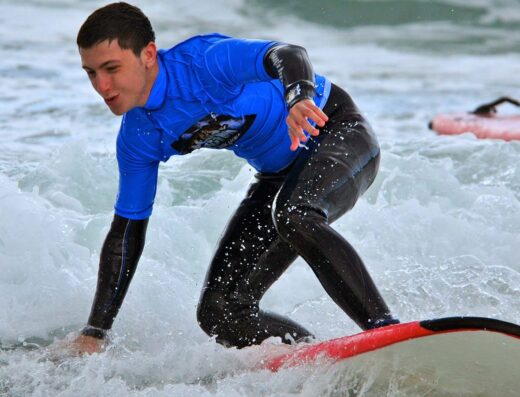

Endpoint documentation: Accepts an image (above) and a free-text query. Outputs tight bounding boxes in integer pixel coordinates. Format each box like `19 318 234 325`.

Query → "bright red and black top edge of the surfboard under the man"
261 317 520 372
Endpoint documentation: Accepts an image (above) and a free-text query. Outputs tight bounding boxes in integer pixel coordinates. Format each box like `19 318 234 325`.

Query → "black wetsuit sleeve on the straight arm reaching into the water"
82 215 148 338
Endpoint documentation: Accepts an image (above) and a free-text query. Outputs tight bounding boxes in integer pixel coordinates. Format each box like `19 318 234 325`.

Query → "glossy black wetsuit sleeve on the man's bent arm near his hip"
264 43 316 109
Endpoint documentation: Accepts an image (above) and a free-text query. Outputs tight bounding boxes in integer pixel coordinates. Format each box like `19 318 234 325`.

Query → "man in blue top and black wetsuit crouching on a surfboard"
71 3 398 353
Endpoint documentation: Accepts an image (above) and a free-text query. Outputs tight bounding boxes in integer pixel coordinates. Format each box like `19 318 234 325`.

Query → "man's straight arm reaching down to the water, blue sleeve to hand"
69 114 160 354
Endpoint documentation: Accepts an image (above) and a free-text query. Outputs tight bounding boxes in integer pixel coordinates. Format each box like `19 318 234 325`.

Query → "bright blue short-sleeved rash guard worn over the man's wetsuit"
115 34 331 220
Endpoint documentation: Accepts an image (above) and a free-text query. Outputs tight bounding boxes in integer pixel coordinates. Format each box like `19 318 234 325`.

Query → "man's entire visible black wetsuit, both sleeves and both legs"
82 39 397 347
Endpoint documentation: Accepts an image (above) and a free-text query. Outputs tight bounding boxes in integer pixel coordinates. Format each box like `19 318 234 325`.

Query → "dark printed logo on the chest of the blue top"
171 113 256 154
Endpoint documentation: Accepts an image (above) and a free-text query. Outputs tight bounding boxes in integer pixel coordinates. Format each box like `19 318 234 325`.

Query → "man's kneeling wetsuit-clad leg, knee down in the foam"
197 174 310 347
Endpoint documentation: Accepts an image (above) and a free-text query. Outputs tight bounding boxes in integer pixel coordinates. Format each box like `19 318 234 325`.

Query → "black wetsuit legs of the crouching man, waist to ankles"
197 86 397 347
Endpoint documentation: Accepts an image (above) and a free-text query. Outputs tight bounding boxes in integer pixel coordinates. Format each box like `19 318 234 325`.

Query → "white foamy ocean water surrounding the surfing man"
0 0 520 397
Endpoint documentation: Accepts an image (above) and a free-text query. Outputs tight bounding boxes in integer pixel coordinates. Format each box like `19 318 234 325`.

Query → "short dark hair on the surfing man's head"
76 2 155 56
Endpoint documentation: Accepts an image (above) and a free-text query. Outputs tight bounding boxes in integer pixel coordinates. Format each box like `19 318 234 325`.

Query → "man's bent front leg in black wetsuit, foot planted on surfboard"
273 87 398 329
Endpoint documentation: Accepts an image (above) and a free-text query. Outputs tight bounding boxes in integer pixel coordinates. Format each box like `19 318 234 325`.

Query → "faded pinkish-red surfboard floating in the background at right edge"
429 97 520 141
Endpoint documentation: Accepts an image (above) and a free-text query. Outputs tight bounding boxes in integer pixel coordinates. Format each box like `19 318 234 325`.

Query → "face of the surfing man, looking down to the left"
79 40 157 115
